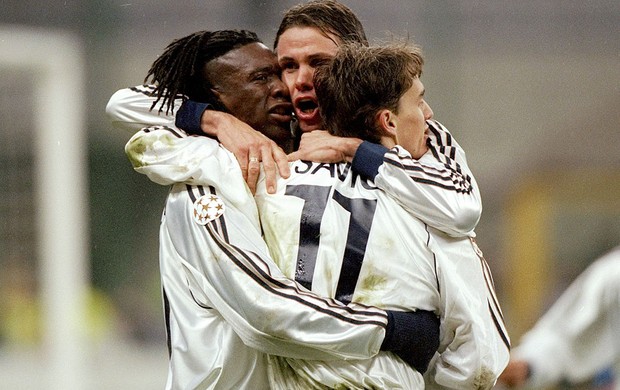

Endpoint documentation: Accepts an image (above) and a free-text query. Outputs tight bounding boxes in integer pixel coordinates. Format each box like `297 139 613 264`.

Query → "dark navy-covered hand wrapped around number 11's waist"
381 310 439 374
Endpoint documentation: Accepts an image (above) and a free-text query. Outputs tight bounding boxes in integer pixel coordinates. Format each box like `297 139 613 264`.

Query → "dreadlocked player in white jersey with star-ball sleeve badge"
118 31 439 389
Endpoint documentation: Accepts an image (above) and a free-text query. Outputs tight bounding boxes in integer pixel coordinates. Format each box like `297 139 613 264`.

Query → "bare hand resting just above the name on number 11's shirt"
288 130 362 163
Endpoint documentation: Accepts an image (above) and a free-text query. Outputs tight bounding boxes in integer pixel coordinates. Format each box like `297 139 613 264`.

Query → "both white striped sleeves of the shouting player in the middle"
106 85 482 237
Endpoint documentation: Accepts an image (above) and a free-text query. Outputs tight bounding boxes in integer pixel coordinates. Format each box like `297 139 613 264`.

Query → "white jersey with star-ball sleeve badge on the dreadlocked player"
127 128 394 389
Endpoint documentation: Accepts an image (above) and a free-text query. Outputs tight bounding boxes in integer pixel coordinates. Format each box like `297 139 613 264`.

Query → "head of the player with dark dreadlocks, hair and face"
145 30 292 151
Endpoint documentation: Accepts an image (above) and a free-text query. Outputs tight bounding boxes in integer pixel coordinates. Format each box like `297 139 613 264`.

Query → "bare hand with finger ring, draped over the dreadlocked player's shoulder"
200 110 290 194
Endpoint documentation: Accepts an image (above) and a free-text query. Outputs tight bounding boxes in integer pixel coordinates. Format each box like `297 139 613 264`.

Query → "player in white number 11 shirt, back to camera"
256 45 509 389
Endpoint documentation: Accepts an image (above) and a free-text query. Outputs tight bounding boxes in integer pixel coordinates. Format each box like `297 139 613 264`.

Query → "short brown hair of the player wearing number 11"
314 43 424 143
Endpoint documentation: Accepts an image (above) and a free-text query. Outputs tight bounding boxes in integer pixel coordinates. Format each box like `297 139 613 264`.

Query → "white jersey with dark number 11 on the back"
256 147 509 389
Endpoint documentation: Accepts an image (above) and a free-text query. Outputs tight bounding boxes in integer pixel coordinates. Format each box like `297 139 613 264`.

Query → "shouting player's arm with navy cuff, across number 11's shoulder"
289 121 482 236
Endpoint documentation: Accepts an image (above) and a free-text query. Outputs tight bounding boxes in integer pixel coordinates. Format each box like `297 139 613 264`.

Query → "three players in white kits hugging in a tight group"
107 0 510 389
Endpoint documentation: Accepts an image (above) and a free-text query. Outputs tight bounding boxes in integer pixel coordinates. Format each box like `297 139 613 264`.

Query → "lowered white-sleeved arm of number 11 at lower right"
425 242 510 390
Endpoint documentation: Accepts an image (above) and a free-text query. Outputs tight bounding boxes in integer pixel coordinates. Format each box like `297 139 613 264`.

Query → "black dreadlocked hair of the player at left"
144 30 261 115
